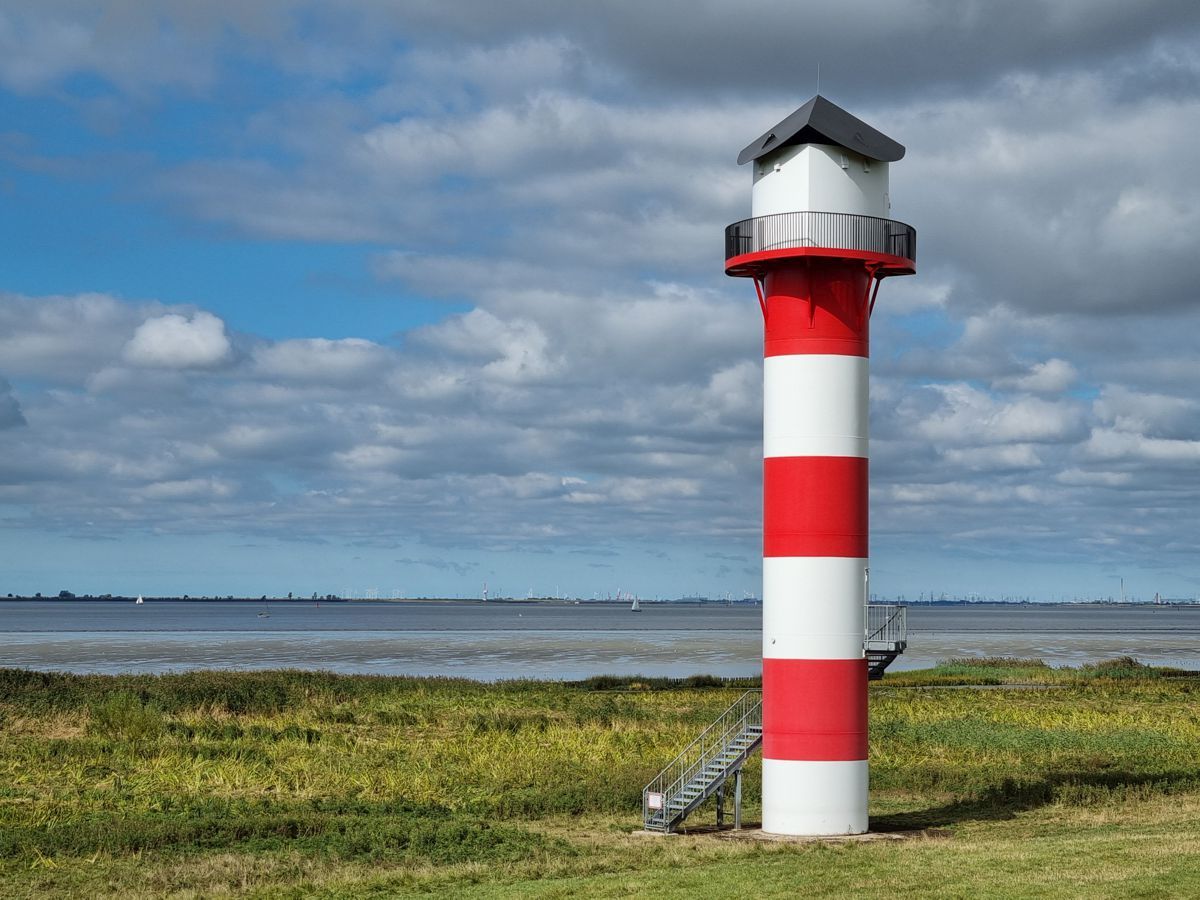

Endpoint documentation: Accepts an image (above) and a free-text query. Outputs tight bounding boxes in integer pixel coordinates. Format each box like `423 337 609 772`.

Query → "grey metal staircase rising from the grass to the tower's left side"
642 691 762 832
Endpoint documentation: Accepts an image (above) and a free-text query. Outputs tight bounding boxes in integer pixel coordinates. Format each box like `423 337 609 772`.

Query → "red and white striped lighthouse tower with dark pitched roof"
725 96 916 834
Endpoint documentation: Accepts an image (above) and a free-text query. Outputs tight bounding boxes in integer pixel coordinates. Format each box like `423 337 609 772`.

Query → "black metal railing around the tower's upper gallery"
725 211 917 262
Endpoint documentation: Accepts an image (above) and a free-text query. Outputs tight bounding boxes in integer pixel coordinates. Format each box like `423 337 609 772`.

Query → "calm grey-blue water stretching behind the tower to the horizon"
0 600 1200 680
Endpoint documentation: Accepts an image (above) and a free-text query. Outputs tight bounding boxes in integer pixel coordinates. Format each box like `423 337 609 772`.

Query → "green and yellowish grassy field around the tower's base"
0 660 1200 898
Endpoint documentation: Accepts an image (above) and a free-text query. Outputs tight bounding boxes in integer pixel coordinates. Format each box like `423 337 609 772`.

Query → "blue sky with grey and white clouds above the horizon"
0 0 1200 599
